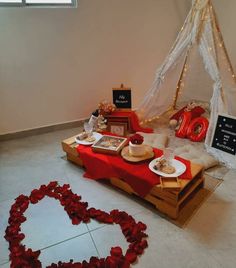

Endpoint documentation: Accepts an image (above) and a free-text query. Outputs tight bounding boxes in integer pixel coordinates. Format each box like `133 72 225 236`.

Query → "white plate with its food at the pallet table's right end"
149 156 186 177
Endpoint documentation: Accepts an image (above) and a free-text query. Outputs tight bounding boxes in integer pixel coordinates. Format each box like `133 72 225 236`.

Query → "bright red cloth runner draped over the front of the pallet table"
77 145 192 197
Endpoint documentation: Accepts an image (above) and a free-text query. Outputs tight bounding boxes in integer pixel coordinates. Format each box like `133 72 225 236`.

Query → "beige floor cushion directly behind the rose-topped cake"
137 132 168 149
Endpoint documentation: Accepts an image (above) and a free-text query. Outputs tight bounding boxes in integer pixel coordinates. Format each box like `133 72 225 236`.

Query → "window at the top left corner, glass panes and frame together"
0 0 77 7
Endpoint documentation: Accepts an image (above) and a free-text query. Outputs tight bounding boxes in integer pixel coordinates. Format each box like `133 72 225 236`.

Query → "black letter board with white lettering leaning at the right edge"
212 115 236 155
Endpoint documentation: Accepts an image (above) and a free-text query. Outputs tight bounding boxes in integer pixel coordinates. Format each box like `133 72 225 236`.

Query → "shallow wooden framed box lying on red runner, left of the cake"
92 135 128 155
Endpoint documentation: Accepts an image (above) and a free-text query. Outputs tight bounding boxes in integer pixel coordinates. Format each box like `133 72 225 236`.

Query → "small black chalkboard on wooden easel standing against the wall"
113 84 132 109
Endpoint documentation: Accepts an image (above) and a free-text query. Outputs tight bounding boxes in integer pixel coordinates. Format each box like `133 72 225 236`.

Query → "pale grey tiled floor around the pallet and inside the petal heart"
0 129 236 268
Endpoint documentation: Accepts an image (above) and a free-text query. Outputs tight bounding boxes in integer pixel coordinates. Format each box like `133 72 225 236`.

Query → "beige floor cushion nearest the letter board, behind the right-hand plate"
174 145 219 169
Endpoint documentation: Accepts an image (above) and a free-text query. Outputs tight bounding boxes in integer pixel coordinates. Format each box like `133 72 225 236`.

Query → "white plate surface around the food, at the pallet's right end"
149 157 186 177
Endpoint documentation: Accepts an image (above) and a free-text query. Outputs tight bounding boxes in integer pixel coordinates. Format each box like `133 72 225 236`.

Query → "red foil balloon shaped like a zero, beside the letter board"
187 116 209 141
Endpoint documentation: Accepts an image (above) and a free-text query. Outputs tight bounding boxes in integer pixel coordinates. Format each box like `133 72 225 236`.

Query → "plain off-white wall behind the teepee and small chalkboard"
0 0 236 134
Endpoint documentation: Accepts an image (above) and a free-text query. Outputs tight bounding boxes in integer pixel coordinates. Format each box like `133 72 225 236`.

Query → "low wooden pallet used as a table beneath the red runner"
62 136 204 219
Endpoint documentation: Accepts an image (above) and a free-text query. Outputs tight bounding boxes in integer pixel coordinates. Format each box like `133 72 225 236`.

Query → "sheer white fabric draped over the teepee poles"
137 0 236 168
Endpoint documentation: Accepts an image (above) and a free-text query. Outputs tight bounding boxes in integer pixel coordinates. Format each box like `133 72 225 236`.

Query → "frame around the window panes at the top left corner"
0 0 76 8
